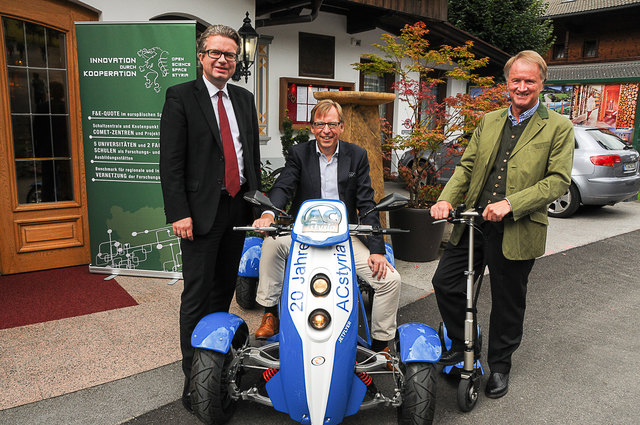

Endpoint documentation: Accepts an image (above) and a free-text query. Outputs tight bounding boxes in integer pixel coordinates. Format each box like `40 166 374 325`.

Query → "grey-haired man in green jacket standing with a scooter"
431 50 574 398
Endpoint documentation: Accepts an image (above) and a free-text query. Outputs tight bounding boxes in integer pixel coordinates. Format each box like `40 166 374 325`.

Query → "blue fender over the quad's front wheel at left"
191 313 244 353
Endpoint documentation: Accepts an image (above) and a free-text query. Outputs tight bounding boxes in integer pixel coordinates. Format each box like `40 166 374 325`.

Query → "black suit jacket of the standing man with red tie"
160 78 260 234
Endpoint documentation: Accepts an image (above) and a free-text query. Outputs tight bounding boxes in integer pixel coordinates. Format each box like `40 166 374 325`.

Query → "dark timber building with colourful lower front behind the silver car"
543 0 640 148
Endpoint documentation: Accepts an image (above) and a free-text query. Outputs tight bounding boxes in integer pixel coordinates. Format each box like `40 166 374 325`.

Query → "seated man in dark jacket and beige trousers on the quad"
253 100 400 351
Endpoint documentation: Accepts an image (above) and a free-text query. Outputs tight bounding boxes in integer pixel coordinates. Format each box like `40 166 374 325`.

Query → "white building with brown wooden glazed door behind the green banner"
0 0 506 274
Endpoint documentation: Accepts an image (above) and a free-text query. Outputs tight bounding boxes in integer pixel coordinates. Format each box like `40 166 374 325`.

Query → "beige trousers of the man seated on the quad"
256 236 401 341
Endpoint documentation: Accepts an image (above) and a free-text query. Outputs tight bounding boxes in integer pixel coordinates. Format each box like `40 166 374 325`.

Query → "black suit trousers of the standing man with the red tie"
180 191 252 378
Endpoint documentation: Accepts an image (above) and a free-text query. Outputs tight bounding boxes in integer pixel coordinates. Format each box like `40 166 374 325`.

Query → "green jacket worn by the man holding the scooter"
438 104 575 260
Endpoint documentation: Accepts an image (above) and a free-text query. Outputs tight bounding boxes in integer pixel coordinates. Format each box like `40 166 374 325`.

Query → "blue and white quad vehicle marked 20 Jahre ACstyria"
191 192 442 425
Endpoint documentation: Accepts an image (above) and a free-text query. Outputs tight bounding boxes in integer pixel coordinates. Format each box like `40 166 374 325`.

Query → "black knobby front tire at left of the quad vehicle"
191 348 236 425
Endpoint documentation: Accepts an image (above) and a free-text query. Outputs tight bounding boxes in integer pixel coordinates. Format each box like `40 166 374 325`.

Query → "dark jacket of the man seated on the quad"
269 140 385 254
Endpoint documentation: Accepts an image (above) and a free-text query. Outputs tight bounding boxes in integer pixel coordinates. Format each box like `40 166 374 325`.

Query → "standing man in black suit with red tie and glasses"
160 25 260 411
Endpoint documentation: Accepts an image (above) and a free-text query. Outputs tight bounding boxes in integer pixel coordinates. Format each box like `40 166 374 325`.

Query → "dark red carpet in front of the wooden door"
0 266 138 329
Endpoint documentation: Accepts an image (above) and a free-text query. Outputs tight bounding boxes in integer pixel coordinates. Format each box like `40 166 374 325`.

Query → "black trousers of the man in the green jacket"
432 222 535 373
